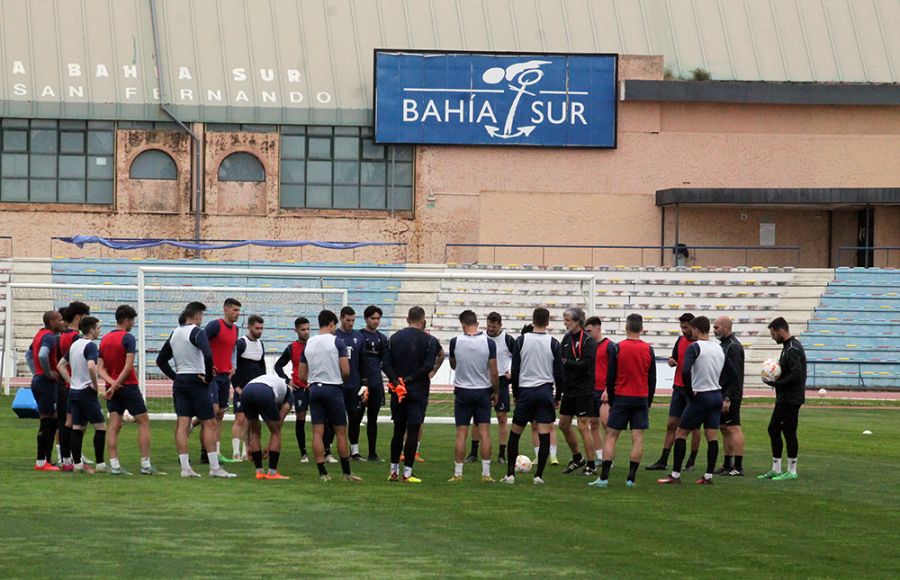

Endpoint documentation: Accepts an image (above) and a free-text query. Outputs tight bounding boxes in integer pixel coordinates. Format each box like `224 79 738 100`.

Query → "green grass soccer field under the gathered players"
0 397 900 578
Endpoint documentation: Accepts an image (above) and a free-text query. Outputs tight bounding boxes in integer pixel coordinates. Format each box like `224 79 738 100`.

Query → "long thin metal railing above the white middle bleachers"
444 244 800 267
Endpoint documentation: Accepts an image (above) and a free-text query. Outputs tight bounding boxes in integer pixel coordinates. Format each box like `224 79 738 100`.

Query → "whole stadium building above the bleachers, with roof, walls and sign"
0 0 900 267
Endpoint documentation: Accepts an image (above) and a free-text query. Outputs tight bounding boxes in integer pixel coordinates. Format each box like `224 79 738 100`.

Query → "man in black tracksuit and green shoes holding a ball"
762 317 806 479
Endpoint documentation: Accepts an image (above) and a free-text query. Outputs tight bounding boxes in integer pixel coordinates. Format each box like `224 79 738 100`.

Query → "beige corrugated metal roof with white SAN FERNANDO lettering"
0 0 900 124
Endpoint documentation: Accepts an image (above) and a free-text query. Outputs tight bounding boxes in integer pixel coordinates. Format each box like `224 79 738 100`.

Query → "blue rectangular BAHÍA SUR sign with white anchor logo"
375 50 618 148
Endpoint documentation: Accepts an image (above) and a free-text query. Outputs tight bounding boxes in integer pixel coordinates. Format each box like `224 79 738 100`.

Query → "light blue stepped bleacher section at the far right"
802 268 900 390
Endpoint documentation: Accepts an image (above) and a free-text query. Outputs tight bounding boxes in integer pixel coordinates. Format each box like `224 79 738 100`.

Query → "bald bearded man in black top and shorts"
713 316 744 477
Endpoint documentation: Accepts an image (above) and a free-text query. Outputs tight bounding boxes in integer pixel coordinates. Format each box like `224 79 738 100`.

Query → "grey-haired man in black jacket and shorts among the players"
557 308 599 475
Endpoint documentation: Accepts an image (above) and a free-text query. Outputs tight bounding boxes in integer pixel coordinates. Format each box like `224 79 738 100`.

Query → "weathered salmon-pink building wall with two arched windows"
0 57 900 267
